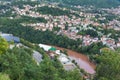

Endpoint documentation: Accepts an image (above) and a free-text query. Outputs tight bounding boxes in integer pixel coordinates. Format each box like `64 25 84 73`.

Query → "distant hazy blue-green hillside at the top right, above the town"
47 0 120 8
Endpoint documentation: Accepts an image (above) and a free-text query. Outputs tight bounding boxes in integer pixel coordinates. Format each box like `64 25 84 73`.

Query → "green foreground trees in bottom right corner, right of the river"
96 48 120 80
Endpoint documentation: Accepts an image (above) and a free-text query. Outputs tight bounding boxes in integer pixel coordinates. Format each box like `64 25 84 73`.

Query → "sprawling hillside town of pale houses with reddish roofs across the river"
8 4 120 51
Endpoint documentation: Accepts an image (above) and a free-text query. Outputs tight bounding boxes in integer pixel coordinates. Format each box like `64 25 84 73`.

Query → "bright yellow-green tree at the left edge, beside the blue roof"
0 37 8 54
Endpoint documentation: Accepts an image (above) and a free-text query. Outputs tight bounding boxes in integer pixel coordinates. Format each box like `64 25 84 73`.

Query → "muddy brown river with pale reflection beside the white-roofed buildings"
56 47 96 74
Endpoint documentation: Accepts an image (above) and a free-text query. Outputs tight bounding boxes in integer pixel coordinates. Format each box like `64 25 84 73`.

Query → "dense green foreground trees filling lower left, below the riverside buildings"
0 38 83 80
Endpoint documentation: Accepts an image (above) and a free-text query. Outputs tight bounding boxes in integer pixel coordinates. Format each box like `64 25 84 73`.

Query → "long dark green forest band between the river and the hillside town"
0 16 104 58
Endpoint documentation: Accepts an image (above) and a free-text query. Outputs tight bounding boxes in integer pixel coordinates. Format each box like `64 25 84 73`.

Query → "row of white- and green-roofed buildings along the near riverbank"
39 44 76 71
